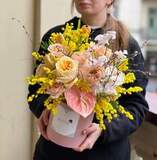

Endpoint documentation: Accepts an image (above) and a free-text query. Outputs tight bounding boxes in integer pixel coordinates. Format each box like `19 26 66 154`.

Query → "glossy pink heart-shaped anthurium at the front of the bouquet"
64 86 96 118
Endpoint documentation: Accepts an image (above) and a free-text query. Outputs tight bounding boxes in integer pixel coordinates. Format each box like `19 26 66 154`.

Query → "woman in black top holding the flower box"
29 0 148 160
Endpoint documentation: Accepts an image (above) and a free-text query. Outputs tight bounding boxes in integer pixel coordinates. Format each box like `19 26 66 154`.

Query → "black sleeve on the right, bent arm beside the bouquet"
100 38 148 143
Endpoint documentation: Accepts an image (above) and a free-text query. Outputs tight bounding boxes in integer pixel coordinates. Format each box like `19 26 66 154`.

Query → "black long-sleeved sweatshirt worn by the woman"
28 17 148 160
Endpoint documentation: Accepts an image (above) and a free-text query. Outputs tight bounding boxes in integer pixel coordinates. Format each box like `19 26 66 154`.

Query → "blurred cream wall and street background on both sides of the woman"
0 0 157 160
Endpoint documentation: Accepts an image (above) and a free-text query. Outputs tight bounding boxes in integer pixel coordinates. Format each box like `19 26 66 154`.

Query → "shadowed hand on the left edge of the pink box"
37 109 50 140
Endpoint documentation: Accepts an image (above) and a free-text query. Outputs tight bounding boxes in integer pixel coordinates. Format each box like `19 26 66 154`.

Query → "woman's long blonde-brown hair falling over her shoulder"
71 0 129 51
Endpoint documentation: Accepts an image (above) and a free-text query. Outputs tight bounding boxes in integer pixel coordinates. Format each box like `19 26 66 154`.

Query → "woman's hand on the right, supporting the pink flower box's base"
73 123 102 152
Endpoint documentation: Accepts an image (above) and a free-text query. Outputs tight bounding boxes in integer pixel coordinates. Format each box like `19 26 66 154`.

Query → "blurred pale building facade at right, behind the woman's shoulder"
116 0 157 92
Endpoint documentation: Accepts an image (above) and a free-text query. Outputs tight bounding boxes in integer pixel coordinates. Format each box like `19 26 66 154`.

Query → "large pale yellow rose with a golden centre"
56 56 78 84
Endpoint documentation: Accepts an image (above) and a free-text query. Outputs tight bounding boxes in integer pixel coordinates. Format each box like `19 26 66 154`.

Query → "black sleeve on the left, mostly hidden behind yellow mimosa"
27 25 63 118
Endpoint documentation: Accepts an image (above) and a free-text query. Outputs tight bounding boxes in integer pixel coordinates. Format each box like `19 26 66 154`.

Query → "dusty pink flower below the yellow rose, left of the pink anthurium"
46 83 65 99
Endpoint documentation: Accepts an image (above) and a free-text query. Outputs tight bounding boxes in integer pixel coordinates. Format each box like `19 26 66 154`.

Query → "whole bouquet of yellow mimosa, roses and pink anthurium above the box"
27 24 142 130
